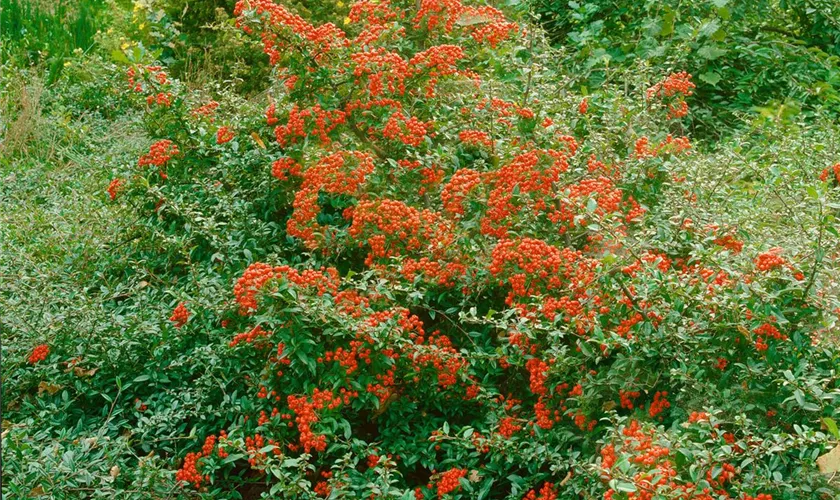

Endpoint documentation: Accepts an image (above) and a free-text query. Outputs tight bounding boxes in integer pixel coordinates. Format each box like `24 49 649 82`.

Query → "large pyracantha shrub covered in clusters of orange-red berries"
106 0 840 500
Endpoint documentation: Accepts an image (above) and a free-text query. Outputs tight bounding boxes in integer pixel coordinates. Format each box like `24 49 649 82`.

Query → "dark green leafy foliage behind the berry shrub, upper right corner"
532 0 840 137
